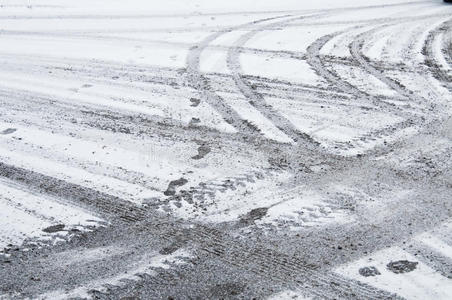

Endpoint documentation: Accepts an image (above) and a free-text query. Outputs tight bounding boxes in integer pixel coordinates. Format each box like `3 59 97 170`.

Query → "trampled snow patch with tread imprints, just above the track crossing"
194 173 353 230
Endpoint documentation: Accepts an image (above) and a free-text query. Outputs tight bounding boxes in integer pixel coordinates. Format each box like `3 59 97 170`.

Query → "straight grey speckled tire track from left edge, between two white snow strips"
0 89 251 143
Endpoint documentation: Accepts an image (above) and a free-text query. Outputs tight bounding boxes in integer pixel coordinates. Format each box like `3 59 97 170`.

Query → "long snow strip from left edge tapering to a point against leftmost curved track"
0 67 235 133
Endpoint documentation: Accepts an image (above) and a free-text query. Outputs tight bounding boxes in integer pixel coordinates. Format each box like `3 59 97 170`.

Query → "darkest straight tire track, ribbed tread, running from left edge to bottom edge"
0 162 393 299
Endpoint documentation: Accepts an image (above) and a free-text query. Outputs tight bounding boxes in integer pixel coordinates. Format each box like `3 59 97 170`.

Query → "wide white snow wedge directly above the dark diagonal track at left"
0 123 260 204
